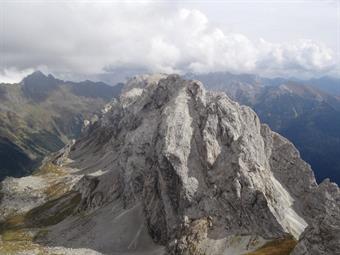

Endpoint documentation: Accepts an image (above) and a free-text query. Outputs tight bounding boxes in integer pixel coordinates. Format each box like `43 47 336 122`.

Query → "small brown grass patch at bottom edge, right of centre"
247 237 297 255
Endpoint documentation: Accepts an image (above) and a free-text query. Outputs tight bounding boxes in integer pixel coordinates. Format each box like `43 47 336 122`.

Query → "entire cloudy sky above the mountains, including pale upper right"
0 0 340 82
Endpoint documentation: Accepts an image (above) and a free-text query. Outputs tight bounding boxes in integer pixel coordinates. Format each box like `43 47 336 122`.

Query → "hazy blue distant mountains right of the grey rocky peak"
186 73 340 183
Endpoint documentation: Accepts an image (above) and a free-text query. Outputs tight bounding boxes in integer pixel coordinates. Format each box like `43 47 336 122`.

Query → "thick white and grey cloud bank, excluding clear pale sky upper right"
0 1 339 80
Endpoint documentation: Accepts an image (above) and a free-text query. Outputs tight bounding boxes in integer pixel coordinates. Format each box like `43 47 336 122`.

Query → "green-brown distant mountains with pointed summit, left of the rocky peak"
0 71 122 180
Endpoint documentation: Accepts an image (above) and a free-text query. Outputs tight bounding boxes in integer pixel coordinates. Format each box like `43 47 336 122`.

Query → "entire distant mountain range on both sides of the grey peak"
0 71 340 183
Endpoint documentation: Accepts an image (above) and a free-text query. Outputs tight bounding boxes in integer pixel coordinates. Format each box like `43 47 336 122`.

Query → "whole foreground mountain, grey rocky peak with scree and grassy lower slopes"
1 75 340 255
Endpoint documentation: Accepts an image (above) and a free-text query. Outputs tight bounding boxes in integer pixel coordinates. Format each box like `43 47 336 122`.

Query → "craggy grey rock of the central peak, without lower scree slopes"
59 75 340 253
